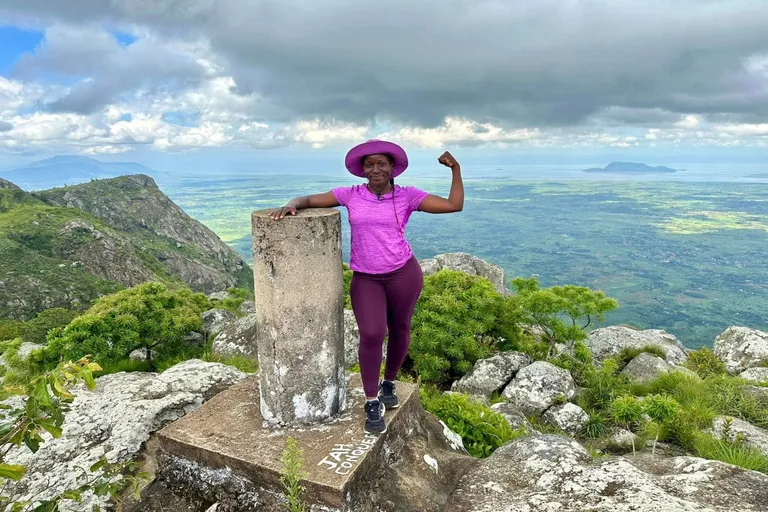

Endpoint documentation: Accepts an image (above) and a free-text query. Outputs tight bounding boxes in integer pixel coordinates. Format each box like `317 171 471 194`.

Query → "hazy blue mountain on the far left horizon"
0 155 156 190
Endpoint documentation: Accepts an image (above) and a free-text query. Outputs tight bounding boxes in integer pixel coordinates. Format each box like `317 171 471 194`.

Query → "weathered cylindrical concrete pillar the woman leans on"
251 209 347 426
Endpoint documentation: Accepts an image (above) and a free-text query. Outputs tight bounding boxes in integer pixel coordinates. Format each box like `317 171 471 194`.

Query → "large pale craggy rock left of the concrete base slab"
4 359 245 511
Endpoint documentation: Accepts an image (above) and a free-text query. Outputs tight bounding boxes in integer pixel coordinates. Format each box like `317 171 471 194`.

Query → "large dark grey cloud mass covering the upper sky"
5 0 768 128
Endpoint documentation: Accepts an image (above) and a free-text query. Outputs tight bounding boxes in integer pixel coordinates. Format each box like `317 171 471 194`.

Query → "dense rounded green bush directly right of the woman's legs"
409 270 504 385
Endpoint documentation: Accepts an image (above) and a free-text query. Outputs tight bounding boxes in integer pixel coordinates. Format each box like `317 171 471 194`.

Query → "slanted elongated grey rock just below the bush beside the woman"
451 352 533 397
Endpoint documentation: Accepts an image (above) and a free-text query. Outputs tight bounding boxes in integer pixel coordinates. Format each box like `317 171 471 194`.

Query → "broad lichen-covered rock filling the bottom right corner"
444 435 768 512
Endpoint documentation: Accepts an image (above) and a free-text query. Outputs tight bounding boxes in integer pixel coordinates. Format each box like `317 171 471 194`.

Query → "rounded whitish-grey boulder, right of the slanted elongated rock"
504 361 576 415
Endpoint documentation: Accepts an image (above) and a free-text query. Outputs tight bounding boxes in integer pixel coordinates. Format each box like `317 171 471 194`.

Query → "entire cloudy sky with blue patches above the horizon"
0 0 768 168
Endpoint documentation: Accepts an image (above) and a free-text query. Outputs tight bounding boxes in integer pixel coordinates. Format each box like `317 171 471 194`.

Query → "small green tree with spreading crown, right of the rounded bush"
512 277 619 357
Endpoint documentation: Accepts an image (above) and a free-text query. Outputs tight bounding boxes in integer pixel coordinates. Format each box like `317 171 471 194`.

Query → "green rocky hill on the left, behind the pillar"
0 174 253 320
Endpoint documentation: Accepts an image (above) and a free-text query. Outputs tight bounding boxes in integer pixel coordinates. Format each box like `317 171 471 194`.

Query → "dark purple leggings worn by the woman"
349 257 424 397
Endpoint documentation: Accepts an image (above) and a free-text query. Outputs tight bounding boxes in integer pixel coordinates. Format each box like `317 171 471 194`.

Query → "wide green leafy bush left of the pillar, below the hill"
44 283 208 367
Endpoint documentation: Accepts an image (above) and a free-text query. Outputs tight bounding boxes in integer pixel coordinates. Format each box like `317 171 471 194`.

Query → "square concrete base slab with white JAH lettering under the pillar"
157 374 421 510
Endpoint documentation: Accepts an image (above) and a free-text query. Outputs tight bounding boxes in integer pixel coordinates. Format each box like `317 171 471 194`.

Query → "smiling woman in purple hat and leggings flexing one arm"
272 140 464 433
